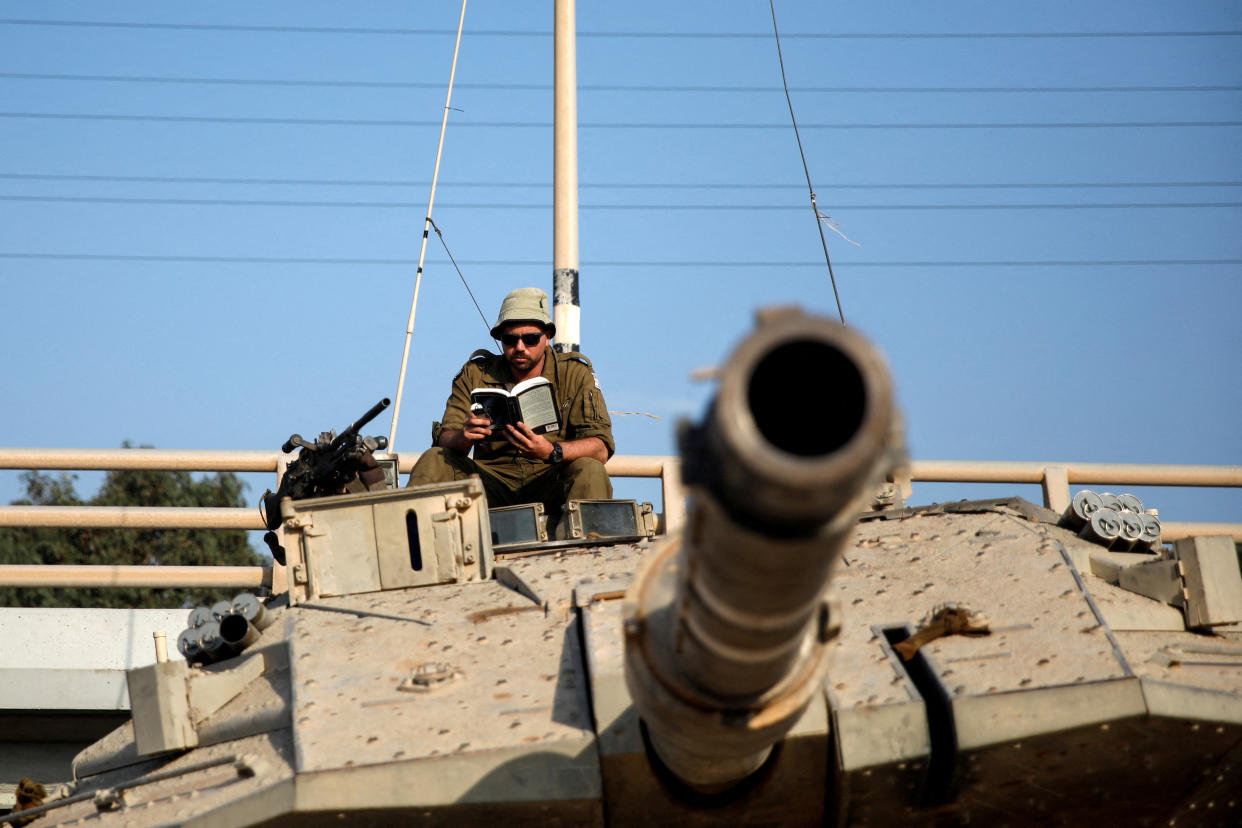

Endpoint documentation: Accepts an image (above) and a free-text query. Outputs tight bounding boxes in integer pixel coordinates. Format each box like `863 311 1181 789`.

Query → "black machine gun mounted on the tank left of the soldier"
260 397 390 565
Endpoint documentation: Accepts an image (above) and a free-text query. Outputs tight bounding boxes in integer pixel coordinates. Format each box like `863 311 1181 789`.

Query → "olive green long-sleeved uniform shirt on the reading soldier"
431 348 616 483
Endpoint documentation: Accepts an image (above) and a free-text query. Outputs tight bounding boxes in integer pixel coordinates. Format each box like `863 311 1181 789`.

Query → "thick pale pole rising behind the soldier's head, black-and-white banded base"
551 0 582 353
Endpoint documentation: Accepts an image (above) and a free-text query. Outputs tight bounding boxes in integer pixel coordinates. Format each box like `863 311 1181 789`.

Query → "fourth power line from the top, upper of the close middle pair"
9 173 1242 190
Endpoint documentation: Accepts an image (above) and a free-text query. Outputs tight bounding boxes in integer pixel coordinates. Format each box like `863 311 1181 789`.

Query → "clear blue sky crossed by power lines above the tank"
0 0 1242 528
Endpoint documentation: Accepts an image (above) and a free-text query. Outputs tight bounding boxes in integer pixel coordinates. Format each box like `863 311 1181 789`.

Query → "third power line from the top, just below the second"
0 112 1242 130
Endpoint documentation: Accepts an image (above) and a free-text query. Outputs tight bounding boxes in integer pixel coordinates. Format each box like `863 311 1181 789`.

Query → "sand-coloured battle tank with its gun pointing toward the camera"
0 309 1242 826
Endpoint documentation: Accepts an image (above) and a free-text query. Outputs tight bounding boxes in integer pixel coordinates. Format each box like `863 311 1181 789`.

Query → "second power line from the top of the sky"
0 72 1242 94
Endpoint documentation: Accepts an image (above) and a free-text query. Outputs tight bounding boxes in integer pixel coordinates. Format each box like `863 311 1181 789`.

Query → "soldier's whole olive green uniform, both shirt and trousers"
410 348 616 514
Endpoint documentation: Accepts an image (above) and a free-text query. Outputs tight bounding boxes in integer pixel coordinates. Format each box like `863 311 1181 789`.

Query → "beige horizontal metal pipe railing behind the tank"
0 448 1242 588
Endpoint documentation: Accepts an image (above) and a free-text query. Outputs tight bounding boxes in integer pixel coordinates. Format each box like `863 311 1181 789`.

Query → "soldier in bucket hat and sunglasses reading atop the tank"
410 288 615 518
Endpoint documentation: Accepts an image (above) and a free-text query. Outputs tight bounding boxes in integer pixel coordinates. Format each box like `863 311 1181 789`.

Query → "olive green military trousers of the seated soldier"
407 447 612 515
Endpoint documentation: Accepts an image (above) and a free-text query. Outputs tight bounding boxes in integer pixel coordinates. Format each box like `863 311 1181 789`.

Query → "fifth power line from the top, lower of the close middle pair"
0 195 1242 212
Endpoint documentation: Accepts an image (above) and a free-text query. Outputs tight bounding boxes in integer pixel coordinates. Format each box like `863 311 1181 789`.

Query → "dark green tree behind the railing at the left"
0 454 265 607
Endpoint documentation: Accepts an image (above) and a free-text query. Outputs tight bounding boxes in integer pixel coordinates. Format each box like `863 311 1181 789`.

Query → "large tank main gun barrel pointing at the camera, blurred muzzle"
625 309 902 791
